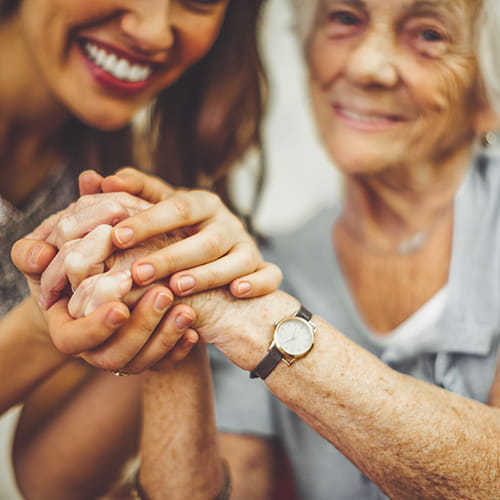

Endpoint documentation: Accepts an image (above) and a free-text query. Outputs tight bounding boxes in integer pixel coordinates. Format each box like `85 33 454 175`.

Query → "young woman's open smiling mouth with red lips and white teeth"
80 40 160 94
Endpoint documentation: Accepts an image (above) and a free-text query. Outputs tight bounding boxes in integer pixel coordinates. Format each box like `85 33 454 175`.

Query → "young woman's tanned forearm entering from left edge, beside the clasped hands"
0 298 68 413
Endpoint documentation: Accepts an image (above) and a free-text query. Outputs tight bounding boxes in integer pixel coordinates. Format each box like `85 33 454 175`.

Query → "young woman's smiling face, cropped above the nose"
17 0 229 130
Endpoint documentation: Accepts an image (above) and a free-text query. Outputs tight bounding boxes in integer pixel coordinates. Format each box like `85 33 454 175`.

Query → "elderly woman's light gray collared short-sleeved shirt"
213 153 500 500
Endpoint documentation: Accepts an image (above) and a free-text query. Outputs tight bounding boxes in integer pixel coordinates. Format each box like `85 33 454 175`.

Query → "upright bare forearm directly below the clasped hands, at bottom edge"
140 345 224 500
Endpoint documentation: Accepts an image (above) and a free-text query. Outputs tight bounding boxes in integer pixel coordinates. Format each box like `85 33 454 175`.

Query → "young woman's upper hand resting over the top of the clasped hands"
80 168 282 298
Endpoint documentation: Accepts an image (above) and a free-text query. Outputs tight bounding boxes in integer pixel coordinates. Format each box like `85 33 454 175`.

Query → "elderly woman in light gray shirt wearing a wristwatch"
11 0 500 500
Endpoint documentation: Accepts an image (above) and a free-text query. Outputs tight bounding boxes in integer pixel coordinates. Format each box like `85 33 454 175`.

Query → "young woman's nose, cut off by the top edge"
120 0 174 54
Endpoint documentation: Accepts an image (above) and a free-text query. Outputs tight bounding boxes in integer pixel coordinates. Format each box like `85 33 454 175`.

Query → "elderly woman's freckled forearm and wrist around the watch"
202 292 500 499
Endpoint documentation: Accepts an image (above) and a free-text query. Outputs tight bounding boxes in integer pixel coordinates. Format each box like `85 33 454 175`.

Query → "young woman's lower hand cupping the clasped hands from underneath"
11 238 198 373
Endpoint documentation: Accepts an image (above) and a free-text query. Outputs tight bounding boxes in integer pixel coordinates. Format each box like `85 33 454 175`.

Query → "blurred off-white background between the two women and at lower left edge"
0 0 339 500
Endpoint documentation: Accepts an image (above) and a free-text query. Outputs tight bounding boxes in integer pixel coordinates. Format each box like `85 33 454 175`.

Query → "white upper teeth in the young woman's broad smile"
84 42 153 82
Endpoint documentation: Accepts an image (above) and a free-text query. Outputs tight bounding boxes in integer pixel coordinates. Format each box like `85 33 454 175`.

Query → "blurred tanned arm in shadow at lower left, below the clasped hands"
14 370 141 500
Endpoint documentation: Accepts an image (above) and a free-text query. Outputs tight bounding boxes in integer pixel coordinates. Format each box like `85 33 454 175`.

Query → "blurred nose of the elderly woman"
346 33 399 88
